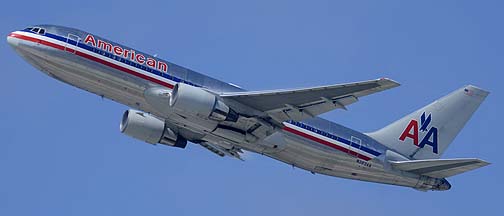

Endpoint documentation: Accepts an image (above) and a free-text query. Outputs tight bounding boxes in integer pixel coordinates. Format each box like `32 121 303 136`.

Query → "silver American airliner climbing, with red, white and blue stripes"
7 25 489 191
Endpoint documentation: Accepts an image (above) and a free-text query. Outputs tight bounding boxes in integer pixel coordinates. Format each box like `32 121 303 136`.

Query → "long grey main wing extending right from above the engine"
221 78 399 123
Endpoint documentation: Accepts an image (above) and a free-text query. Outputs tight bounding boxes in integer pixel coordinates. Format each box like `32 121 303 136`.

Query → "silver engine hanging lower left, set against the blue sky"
119 110 187 148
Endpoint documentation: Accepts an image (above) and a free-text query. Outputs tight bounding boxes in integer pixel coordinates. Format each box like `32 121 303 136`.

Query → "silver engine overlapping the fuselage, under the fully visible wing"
170 83 238 122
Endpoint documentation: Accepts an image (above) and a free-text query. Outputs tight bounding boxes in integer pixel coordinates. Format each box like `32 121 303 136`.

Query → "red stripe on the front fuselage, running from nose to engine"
9 33 173 89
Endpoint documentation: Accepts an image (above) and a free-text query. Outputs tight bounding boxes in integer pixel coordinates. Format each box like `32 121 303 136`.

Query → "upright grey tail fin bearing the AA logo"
367 85 489 159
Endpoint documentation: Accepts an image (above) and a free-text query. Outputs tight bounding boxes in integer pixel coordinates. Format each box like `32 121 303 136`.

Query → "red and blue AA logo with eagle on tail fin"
399 112 438 154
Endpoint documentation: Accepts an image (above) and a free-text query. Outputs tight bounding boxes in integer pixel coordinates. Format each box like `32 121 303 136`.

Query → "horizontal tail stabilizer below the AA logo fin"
390 158 490 178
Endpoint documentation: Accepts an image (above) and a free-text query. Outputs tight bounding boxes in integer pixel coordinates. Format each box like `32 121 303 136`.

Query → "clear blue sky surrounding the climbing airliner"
0 0 504 216
